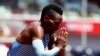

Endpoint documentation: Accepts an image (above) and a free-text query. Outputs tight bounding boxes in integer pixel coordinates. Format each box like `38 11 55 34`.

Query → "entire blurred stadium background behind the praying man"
0 0 100 56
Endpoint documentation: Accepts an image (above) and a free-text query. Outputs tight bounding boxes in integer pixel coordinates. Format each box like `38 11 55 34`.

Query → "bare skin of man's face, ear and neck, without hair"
41 12 62 35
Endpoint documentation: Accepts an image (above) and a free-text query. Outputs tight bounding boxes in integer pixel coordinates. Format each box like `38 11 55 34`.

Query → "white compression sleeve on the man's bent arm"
32 39 60 56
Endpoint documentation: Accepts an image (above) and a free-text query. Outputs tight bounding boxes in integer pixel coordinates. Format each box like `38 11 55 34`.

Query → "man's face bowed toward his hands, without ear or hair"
45 13 62 32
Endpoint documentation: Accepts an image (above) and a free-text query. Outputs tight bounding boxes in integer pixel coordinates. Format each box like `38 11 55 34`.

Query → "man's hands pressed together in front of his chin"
53 27 68 48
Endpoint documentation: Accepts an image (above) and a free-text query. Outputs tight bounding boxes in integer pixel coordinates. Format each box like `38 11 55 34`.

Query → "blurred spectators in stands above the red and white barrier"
0 0 100 20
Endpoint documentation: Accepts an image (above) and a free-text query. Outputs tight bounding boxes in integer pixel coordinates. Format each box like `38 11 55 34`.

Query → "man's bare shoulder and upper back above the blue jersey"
16 22 44 44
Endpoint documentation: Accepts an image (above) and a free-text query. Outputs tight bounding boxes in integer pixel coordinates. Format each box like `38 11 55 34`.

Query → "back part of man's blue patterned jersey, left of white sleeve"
7 41 37 56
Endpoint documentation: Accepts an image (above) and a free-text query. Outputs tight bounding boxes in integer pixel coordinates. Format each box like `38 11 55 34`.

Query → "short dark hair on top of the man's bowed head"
40 4 63 21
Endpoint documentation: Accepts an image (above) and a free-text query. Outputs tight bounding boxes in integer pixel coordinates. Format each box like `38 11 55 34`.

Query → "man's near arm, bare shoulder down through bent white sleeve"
30 24 60 56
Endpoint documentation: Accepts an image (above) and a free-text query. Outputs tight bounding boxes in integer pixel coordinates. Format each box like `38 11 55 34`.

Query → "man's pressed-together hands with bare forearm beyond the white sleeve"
50 27 68 56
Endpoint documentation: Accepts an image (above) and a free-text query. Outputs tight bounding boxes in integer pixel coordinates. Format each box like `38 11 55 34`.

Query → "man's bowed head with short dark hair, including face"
40 4 63 33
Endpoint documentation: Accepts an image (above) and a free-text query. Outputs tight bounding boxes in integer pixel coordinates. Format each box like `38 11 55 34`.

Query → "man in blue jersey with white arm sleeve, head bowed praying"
8 5 66 56
